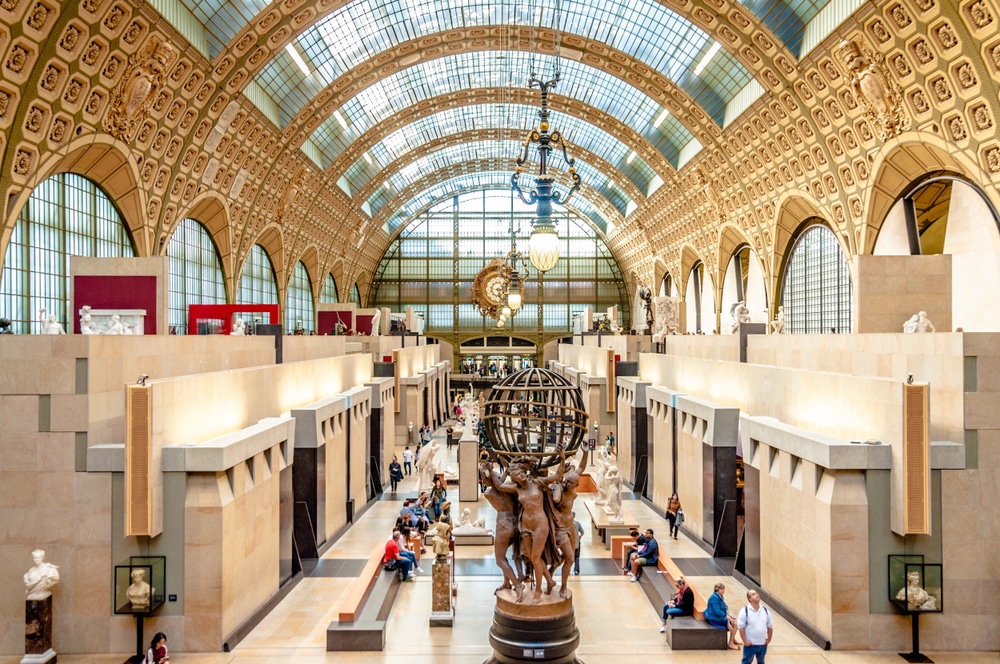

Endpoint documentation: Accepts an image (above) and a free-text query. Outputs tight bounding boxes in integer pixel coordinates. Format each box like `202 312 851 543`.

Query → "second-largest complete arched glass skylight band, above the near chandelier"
292 51 693 174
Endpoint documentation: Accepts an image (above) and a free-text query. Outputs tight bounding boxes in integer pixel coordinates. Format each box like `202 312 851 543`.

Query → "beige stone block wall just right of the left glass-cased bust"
184 449 282 652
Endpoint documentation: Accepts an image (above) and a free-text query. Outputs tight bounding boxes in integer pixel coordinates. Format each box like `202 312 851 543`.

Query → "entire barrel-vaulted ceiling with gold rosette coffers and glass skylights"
0 0 1000 306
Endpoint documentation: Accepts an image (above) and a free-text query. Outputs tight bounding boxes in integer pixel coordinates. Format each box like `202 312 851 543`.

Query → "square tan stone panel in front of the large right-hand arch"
851 254 952 334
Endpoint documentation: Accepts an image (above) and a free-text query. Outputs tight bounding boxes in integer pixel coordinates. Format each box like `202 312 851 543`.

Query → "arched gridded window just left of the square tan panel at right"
781 224 851 334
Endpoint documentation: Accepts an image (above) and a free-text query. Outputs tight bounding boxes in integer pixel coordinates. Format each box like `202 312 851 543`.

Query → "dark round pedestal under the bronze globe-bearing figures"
486 588 580 664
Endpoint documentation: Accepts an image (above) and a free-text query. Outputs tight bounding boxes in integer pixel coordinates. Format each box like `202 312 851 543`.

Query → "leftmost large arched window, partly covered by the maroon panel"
0 173 135 334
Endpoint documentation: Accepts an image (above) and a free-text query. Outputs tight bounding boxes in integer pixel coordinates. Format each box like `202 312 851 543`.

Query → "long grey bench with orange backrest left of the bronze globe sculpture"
326 544 400 652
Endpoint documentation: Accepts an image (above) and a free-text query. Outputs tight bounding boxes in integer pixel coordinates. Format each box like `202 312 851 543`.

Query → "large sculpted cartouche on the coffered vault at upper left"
104 39 174 142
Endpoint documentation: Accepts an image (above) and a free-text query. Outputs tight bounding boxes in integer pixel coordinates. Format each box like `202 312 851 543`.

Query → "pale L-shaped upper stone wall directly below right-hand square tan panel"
747 332 964 441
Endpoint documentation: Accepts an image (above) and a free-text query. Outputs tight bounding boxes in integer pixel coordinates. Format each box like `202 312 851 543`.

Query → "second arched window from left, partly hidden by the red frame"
167 219 226 334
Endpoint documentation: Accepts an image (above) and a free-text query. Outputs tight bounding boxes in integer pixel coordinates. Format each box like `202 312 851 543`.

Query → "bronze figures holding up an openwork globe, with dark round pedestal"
479 369 588 664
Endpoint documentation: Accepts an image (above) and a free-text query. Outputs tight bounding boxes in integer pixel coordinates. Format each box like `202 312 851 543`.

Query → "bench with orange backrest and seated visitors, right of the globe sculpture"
611 536 729 650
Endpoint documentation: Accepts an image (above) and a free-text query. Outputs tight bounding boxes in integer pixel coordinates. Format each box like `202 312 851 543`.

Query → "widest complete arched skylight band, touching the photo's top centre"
252 0 751 126
